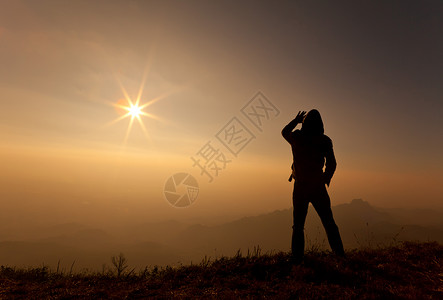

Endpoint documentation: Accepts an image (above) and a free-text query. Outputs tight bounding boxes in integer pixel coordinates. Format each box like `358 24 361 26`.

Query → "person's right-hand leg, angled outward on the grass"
311 187 345 256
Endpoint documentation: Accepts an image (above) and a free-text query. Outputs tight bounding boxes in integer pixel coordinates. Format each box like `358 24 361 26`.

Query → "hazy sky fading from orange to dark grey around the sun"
0 0 443 226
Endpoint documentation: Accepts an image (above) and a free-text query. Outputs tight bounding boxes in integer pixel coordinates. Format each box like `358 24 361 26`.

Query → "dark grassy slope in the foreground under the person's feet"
0 242 443 299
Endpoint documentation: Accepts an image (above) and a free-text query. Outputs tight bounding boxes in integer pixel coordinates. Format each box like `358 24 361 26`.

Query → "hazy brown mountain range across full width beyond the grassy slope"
0 199 443 270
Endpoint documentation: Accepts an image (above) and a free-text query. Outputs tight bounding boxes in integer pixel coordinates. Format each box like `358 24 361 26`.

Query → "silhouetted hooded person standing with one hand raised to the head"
281 109 344 263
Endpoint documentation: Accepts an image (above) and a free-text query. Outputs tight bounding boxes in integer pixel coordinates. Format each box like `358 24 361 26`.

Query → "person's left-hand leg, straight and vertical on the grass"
291 184 309 263
